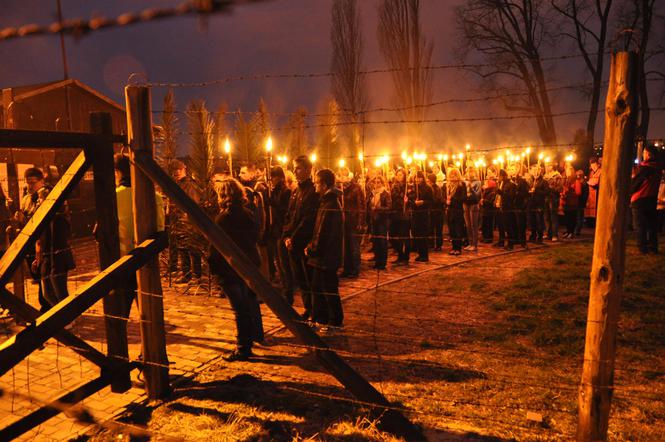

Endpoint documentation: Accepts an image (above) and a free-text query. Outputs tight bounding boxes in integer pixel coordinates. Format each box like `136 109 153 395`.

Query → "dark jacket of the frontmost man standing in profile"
307 189 342 270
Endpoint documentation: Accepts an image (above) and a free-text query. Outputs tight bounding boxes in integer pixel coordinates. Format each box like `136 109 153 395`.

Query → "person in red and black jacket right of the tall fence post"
630 145 663 254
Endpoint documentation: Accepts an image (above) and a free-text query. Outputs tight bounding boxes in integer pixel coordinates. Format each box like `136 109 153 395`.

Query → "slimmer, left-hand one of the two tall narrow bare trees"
330 0 369 158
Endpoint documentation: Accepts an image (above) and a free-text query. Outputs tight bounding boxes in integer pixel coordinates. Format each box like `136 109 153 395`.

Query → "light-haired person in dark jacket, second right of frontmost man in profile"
368 175 392 270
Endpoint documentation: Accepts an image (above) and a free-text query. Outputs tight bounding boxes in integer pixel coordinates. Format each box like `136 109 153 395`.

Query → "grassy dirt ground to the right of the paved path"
91 243 665 441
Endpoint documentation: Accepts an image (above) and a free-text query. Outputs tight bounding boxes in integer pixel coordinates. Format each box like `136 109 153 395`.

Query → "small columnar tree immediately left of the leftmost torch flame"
185 100 215 192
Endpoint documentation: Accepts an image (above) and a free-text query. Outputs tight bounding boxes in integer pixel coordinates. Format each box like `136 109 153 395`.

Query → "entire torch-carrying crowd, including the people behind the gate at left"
0 146 665 361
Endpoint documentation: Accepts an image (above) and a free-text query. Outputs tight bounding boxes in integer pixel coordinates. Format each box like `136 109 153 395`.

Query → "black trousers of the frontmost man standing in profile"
312 268 344 326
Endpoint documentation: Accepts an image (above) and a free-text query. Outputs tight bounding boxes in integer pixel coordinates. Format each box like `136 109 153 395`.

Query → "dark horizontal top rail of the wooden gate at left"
0 129 112 149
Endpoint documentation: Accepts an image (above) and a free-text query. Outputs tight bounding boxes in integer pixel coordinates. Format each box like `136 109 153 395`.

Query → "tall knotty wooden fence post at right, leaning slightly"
577 52 637 442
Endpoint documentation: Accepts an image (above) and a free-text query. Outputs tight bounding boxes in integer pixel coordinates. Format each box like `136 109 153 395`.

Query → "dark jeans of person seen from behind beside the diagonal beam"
220 281 263 353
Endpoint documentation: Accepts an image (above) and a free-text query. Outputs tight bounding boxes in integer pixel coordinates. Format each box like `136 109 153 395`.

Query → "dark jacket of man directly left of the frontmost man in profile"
282 179 320 252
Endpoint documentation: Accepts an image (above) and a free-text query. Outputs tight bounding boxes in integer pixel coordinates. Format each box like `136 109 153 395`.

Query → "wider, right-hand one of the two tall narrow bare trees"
378 0 434 143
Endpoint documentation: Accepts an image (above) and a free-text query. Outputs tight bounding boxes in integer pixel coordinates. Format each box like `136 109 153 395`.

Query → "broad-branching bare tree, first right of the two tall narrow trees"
455 0 557 144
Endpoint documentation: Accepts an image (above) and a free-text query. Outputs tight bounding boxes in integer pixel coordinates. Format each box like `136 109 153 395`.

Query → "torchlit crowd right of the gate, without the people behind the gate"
160 146 665 360
